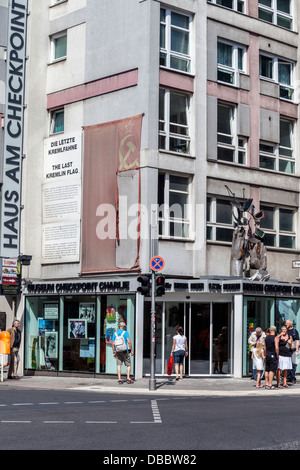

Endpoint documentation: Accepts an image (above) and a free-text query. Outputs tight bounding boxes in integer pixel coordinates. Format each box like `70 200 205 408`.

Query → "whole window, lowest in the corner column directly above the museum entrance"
158 173 190 238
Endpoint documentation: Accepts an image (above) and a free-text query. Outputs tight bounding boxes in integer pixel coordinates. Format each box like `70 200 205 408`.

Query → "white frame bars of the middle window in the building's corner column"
159 87 191 155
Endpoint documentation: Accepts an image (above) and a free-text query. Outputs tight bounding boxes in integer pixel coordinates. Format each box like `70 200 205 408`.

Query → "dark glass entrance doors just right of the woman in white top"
188 302 232 375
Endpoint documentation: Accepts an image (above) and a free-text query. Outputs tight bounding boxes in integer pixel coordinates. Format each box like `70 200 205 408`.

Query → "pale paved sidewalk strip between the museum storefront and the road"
0 374 300 397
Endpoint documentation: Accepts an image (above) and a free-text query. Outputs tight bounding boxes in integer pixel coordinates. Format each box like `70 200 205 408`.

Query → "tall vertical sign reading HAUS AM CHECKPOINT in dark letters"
0 0 27 258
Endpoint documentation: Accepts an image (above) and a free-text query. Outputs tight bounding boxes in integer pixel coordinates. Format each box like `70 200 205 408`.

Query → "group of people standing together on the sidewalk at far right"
248 320 299 389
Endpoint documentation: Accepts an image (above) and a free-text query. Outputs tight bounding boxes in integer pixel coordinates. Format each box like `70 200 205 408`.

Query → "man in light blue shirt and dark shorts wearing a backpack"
112 322 133 384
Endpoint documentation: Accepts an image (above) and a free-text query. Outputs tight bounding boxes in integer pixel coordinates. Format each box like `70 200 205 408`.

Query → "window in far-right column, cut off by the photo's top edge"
258 0 293 29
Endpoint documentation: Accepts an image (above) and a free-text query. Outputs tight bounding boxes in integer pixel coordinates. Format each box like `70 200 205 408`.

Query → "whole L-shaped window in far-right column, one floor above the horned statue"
259 119 295 174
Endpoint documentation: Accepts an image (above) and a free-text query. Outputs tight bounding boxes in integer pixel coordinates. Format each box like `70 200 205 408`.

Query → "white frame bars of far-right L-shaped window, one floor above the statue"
259 118 296 175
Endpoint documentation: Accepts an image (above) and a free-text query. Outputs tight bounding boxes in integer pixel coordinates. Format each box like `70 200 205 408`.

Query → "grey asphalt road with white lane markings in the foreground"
0 389 300 454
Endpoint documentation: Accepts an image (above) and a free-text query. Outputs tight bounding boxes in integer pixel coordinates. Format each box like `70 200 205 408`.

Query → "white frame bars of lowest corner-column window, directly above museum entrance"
158 173 192 241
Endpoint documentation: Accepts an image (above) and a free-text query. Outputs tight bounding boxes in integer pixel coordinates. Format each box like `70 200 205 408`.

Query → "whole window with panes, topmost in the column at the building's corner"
160 8 191 72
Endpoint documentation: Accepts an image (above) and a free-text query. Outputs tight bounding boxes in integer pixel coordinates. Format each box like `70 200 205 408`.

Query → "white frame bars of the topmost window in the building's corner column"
160 7 193 74
